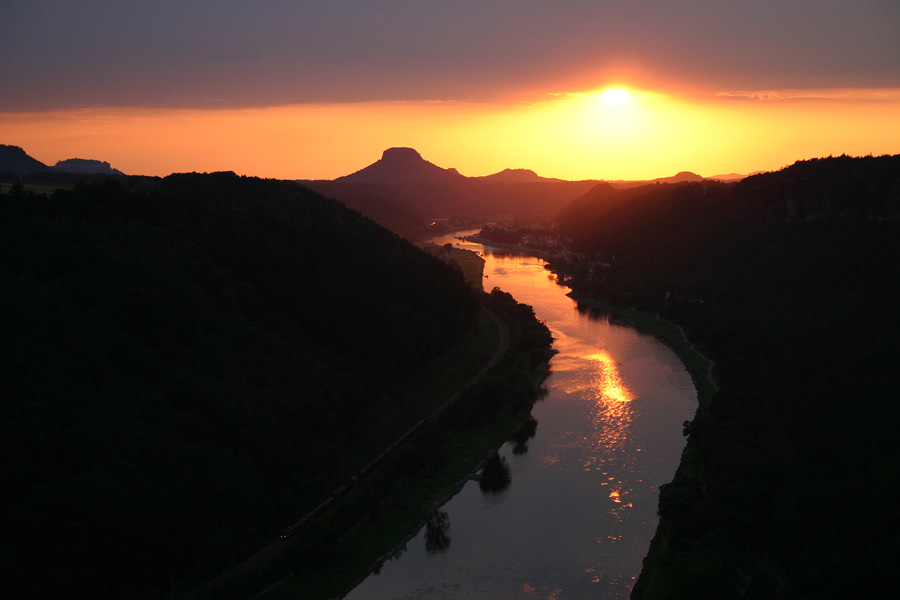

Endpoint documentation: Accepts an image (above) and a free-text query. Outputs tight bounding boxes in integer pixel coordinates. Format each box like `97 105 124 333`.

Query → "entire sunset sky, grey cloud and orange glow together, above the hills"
0 0 900 179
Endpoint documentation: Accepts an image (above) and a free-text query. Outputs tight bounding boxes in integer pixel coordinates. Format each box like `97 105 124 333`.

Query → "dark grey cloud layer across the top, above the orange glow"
0 0 900 111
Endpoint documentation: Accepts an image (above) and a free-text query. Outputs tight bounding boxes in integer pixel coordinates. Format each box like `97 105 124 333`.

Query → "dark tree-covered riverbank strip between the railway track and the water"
246 295 549 600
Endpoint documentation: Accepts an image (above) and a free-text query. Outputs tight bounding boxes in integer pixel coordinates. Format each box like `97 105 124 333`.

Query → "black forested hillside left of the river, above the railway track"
0 173 479 598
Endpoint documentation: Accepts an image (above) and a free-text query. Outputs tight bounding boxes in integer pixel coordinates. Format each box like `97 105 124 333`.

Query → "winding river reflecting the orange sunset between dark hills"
346 237 697 600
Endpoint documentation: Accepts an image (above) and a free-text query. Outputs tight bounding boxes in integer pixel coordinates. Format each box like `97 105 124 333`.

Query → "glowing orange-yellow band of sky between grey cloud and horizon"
0 82 900 179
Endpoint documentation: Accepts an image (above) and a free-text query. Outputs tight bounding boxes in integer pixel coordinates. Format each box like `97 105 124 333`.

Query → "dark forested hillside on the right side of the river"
556 156 900 599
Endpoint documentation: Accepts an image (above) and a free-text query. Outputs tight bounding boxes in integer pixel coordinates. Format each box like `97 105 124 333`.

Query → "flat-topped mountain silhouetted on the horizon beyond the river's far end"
334 148 467 186
